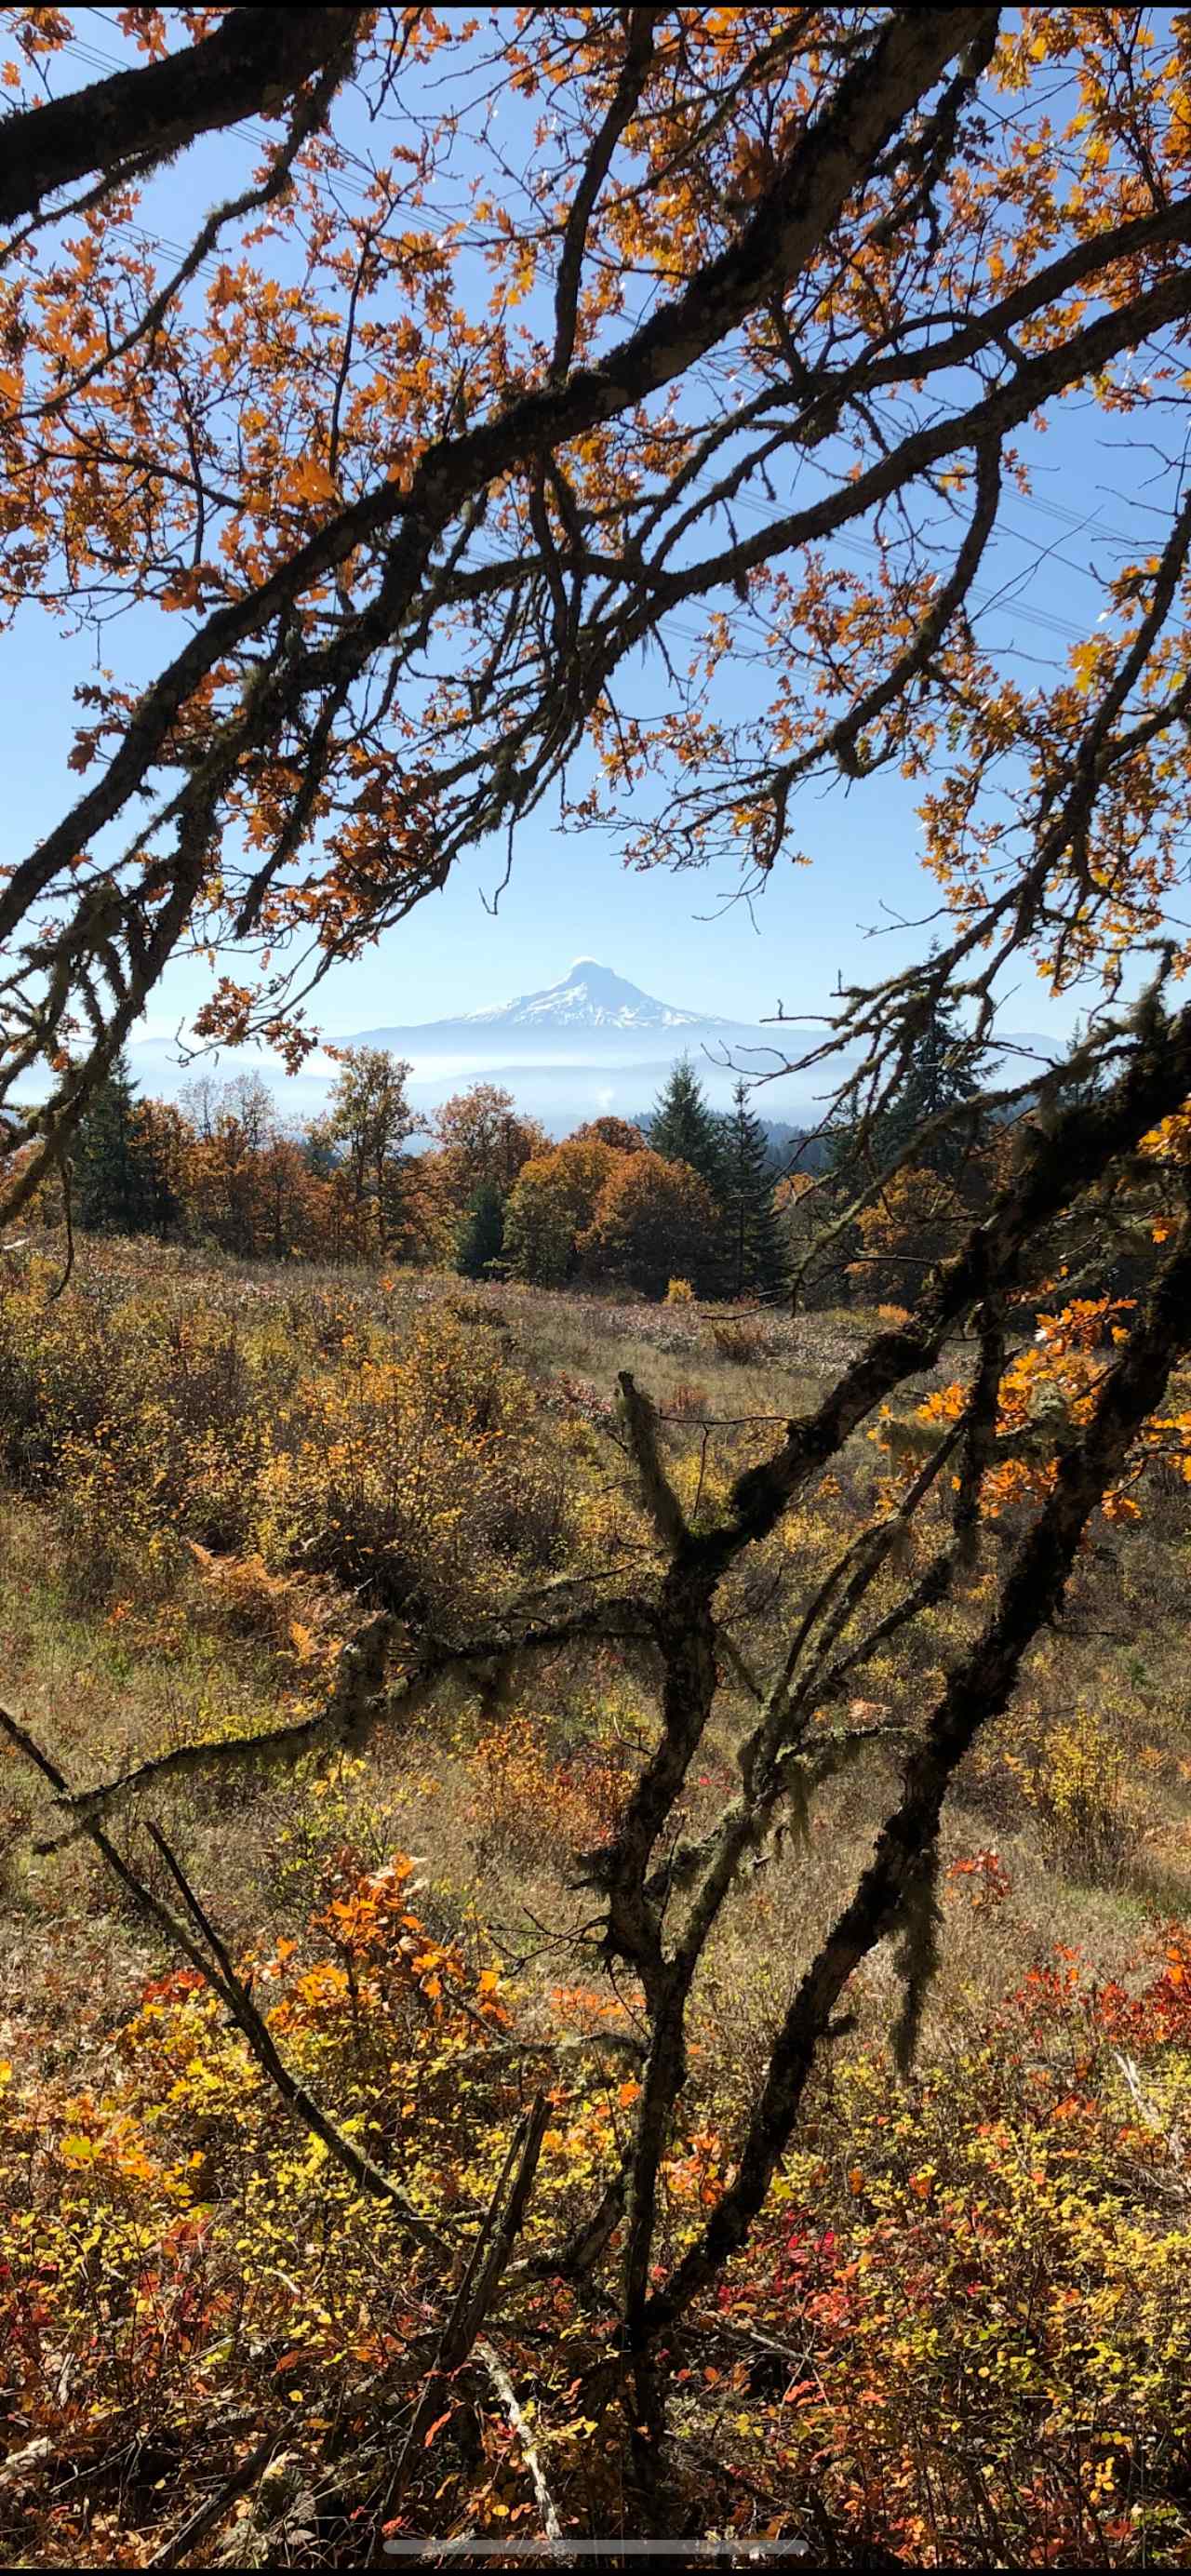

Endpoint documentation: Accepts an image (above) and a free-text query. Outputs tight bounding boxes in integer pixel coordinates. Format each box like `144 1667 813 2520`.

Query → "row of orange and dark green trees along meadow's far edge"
16 1009 1072 1306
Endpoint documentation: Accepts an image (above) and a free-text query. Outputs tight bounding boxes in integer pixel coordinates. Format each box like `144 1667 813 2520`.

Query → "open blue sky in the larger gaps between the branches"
0 10 1165 1076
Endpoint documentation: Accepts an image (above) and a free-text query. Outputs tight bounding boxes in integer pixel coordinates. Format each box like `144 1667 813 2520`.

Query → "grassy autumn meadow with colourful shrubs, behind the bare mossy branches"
0 1242 1191 2566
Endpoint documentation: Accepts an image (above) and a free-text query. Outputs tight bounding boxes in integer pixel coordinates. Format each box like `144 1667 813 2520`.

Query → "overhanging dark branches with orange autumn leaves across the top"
0 7 1191 1195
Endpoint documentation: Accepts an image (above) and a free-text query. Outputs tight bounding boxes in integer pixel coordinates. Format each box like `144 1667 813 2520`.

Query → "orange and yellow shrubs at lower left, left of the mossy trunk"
0 1855 536 2563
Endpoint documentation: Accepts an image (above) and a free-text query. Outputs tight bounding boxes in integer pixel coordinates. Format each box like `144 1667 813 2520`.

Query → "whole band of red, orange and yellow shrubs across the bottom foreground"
0 1906 1191 2569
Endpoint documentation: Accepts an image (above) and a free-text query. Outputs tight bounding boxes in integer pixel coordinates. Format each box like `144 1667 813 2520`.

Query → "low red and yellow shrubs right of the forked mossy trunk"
701 1932 1191 2566
